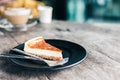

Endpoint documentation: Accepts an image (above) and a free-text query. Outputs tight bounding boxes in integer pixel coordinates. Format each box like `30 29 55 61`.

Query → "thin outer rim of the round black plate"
9 39 88 70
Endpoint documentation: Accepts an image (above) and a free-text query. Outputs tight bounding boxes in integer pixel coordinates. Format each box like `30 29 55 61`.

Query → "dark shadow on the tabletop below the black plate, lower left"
0 58 59 77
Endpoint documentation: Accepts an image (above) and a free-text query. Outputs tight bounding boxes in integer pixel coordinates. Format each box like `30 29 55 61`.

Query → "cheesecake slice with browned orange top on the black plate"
24 37 63 61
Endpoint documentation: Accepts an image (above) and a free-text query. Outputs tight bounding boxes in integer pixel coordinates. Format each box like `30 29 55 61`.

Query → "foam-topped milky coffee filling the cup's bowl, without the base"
5 8 31 25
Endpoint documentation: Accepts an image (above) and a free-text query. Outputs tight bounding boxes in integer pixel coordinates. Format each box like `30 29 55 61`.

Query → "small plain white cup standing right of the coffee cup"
38 6 53 23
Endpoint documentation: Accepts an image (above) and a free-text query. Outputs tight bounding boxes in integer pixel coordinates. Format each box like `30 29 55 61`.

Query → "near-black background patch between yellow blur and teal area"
39 0 67 20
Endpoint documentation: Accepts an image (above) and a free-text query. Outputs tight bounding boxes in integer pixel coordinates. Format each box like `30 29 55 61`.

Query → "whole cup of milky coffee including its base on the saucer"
5 8 31 31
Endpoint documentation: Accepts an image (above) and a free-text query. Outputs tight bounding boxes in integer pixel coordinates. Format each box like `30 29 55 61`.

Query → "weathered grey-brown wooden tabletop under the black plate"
0 21 120 80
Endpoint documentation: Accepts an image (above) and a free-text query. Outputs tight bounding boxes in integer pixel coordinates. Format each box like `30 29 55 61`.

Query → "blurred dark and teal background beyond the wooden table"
39 0 120 23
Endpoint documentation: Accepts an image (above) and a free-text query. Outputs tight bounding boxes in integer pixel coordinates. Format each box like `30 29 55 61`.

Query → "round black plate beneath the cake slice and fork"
10 39 87 70
